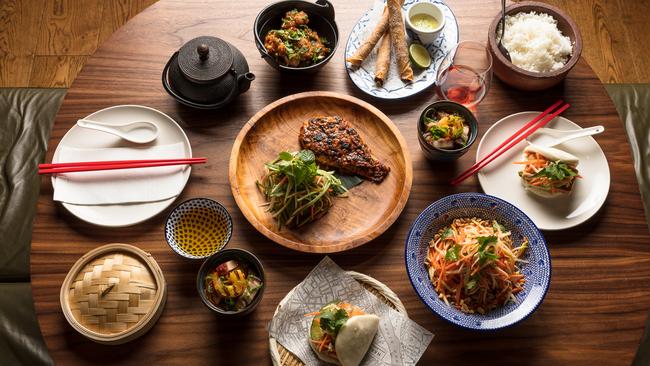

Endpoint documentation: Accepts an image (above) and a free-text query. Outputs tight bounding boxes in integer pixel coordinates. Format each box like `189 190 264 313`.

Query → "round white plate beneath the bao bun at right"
476 112 610 230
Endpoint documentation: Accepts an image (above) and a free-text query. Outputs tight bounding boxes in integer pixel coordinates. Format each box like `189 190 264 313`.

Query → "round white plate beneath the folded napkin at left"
52 105 192 227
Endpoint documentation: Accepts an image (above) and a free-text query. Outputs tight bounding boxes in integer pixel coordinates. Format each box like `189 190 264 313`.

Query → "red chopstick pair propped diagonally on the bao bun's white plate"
450 100 570 185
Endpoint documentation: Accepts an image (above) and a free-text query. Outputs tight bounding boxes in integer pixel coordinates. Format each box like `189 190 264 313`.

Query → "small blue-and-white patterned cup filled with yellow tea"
165 198 232 259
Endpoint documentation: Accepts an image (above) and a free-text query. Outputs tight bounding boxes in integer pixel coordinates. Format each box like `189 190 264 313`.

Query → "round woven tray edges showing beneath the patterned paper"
269 271 408 366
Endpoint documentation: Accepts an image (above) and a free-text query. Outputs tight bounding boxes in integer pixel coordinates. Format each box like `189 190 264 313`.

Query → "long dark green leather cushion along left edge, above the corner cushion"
0 88 65 282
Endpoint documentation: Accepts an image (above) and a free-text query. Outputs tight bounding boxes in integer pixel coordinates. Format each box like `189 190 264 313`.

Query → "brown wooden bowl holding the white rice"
488 1 582 90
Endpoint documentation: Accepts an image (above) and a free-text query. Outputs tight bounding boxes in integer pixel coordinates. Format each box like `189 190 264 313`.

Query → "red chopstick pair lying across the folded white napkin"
38 158 208 174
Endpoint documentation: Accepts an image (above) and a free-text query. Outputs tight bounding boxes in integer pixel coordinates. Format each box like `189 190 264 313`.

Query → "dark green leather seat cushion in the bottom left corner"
0 282 53 366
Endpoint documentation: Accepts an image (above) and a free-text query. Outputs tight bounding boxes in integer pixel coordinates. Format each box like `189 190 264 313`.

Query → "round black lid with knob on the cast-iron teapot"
178 36 233 83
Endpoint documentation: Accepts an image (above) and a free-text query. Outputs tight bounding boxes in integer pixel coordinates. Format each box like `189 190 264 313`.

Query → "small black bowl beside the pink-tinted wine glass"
418 100 478 161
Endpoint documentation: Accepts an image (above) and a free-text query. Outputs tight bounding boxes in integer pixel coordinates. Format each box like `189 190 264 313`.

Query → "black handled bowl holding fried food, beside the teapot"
253 0 339 74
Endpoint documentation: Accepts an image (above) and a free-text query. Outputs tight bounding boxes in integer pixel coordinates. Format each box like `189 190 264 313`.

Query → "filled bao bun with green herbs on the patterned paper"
309 301 379 366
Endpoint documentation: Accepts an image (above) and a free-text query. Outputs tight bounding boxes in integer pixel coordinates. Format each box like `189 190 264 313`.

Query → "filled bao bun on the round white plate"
517 144 581 198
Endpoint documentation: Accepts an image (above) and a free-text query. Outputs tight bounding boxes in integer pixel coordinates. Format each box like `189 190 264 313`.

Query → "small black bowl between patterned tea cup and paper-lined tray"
196 248 266 317
